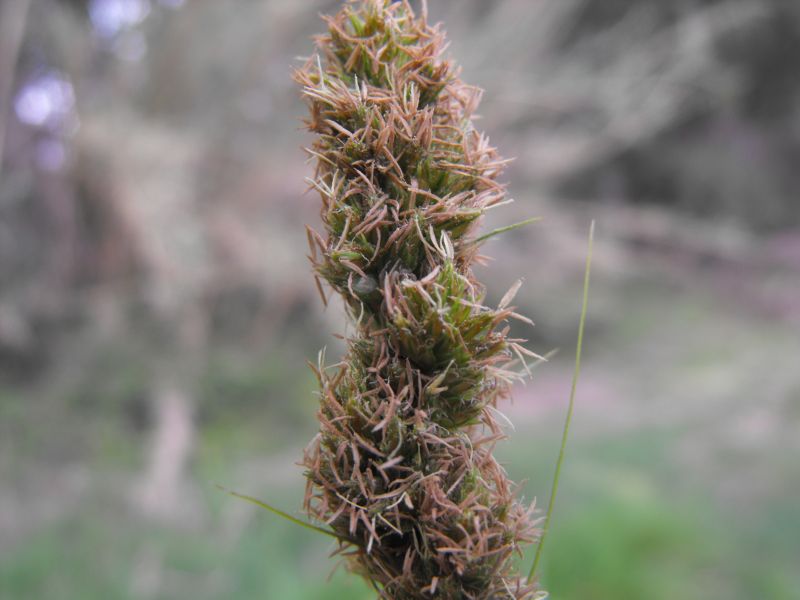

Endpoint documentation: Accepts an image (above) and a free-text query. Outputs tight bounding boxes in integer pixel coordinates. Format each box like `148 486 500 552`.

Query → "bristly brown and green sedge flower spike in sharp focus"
295 0 536 600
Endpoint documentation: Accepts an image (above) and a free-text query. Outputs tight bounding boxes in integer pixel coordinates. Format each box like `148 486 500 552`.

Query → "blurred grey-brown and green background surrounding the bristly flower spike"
0 0 800 600
